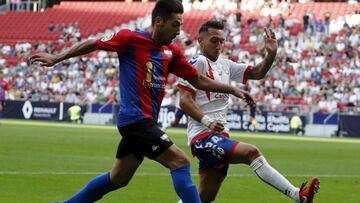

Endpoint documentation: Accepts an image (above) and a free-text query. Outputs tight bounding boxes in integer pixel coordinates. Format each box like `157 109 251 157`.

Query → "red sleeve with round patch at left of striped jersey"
96 29 132 53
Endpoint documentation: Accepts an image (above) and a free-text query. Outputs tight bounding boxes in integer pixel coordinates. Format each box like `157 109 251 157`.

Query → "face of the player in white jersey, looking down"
199 28 225 61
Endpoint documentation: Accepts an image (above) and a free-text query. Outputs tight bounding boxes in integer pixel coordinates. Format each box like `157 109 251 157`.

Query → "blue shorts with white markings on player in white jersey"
191 133 238 177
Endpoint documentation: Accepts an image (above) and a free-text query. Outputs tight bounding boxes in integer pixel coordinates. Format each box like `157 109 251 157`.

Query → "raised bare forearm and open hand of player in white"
246 28 278 80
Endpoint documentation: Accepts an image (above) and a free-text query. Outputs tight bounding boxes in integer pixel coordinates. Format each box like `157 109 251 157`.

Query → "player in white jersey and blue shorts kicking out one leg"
178 21 320 203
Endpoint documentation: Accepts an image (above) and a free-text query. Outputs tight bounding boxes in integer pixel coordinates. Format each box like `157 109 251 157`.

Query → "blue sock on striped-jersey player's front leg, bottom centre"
171 165 201 203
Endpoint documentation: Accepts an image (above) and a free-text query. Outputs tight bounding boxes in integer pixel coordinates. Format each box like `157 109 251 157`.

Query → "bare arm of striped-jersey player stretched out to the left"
30 39 97 66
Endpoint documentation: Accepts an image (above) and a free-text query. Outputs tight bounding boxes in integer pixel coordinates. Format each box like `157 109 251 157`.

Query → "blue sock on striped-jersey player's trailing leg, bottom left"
65 172 117 203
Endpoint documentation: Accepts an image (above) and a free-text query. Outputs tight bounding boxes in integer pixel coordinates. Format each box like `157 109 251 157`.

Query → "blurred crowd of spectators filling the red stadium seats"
0 1 360 112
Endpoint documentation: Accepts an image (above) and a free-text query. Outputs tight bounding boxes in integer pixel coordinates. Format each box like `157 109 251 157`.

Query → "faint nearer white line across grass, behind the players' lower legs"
0 171 360 178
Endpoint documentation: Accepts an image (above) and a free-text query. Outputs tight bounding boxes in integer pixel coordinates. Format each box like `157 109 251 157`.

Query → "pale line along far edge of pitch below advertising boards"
2 120 360 144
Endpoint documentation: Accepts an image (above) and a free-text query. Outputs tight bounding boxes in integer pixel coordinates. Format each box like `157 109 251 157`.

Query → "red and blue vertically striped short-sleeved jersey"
96 29 199 127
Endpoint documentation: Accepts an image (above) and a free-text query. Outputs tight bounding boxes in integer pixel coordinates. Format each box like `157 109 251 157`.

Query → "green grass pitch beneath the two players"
0 120 360 203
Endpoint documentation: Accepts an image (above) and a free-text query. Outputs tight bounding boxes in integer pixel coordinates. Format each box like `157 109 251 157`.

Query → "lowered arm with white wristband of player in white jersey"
179 88 224 132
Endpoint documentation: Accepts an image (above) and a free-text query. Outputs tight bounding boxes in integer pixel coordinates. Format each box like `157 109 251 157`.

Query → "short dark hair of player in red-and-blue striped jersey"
151 0 184 25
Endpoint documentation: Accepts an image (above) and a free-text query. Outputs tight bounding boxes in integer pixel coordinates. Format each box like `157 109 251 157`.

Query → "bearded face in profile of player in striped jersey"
159 13 182 45
